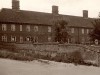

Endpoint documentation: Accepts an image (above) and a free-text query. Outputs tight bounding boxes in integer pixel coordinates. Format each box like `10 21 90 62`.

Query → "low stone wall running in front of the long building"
0 43 100 66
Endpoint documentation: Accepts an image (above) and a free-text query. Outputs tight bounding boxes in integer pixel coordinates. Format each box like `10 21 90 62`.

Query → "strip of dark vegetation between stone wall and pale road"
0 49 97 66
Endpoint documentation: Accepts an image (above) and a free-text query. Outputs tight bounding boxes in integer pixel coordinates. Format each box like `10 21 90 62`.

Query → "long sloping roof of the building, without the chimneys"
0 8 93 28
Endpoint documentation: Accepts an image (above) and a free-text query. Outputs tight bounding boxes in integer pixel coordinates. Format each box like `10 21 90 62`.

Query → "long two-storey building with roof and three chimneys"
0 0 93 43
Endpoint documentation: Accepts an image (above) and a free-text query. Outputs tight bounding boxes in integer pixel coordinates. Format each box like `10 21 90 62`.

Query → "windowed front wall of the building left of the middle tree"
0 23 52 43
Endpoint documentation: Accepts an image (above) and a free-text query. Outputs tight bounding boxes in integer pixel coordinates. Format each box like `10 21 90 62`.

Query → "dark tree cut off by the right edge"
90 19 100 41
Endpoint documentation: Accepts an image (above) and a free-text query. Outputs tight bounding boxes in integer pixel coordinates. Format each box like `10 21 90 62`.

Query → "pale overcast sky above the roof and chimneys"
0 0 100 17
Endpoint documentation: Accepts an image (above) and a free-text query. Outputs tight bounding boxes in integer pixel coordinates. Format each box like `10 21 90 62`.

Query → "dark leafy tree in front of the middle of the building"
54 20 69 43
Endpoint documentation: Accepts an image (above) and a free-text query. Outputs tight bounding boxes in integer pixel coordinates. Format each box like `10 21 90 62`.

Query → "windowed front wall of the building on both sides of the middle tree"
0 23 92 43
